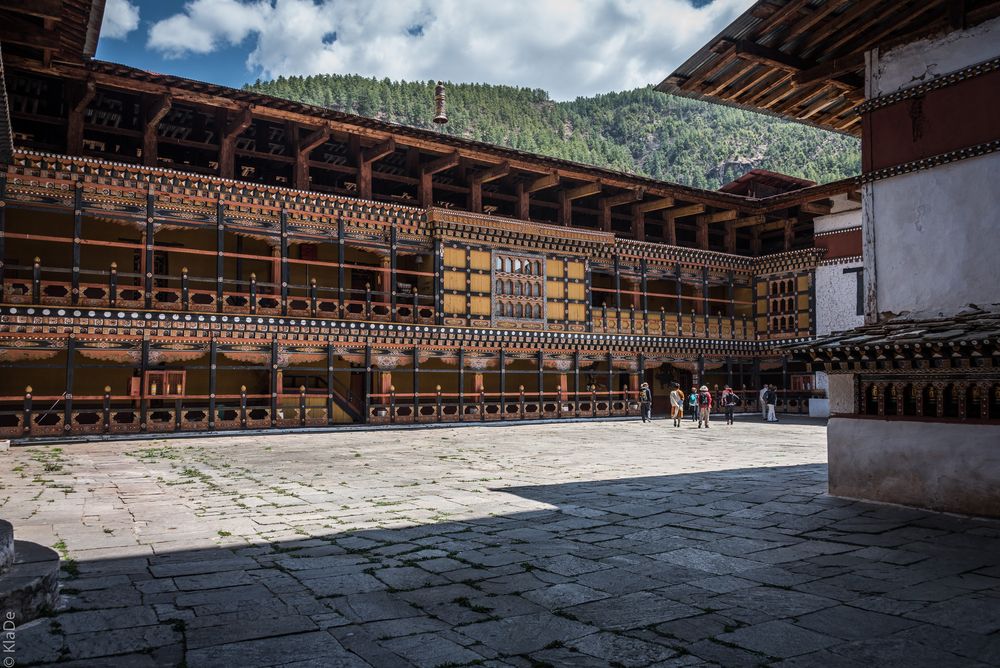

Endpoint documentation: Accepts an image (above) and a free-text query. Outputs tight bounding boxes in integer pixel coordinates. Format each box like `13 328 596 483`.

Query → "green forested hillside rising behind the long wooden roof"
246 75 860 188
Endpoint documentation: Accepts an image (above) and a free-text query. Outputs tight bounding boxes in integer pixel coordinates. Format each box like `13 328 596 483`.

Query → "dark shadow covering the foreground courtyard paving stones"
11 465 1000 668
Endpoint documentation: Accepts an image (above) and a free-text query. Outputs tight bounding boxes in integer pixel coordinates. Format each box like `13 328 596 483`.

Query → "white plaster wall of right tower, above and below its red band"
864 19 1000 317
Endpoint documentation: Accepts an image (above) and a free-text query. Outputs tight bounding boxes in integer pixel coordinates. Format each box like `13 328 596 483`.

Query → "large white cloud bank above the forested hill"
149 0 751 99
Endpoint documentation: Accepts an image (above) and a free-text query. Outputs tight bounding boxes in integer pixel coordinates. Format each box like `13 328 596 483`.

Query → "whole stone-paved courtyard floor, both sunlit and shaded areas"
0 421 1000 668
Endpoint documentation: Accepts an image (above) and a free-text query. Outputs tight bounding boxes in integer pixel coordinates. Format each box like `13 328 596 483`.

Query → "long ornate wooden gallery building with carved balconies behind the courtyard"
0 0 857 438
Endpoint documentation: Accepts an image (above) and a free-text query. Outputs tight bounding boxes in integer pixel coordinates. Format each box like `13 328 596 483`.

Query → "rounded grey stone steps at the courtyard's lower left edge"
0 520 59 626
